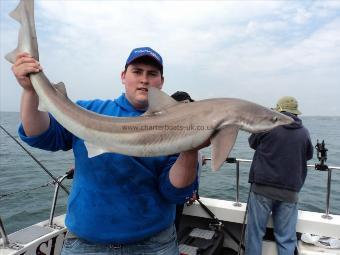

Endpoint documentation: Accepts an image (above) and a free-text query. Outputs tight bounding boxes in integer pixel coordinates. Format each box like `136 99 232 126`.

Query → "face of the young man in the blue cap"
121 63 164 109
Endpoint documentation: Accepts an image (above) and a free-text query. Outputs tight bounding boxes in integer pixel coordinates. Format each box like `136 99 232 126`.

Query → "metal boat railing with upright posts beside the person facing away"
205 158 340 219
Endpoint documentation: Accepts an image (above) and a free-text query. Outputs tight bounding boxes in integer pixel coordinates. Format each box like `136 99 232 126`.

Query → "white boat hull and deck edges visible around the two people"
0 198 340 255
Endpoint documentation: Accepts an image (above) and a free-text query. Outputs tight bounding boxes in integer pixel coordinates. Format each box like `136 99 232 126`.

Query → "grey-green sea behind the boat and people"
0 112 340 233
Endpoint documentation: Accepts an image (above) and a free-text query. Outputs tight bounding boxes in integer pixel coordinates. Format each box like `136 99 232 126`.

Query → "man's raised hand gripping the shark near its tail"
12 52 42 90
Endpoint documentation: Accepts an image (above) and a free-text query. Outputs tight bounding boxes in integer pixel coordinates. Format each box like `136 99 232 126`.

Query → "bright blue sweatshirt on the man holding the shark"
19 94 197 244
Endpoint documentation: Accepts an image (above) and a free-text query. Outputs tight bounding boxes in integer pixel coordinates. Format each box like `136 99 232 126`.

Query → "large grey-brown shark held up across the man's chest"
6 0 293 170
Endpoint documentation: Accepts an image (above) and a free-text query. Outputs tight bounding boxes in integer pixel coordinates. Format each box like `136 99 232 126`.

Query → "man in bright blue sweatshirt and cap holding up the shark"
12 47 200 255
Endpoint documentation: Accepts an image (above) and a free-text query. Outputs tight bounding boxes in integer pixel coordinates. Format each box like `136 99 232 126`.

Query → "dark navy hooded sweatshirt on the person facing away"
249 112 313 192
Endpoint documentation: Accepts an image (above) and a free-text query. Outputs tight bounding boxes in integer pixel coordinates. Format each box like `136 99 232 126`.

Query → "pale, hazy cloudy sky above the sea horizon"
0 0 340 116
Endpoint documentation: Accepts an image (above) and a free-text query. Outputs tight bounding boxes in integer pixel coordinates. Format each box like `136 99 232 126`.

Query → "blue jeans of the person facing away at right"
245 192 298 255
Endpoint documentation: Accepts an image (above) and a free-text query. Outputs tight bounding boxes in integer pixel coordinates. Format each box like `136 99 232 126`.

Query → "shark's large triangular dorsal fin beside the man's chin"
144 87 178 115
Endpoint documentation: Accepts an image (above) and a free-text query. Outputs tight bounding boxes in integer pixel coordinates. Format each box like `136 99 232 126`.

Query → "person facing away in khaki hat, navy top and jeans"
245 96 313 255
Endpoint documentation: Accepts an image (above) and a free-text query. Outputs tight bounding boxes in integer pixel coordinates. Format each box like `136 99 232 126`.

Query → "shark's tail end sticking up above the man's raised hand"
5 0 39 64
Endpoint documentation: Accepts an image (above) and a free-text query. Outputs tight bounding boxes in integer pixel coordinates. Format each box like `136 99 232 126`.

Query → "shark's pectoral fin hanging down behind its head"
211 125 239 171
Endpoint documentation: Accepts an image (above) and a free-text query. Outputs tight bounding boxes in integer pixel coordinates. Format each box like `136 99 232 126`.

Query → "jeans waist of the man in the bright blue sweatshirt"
61 225 179 255
